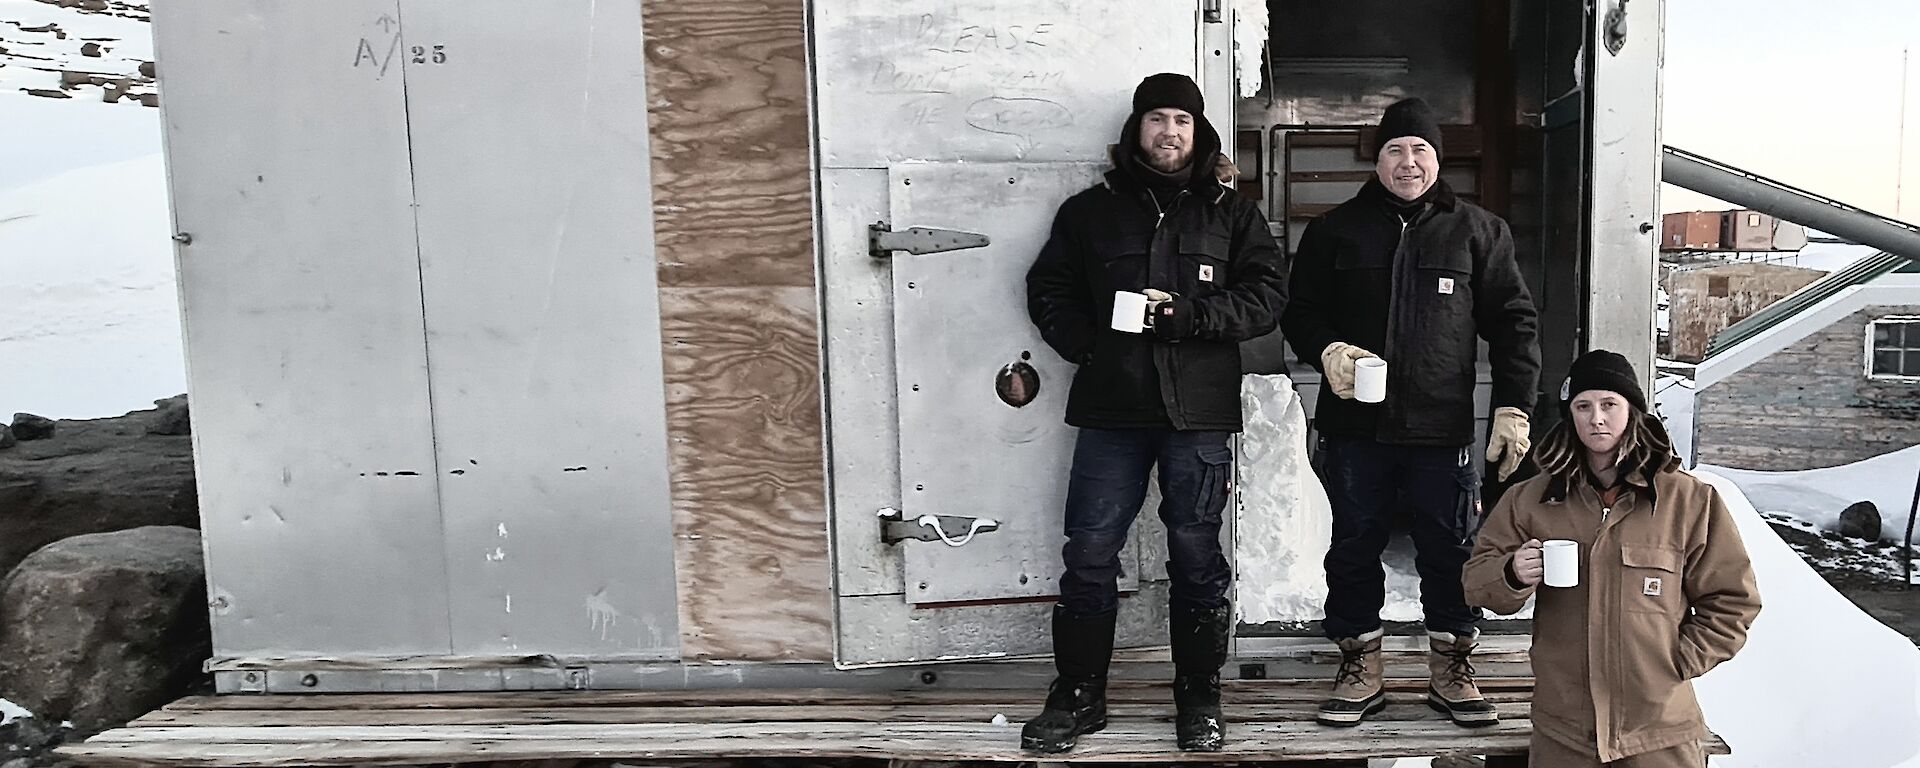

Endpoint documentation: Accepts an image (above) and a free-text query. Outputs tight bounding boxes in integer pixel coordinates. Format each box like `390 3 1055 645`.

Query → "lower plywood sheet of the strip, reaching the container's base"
660 288 831 660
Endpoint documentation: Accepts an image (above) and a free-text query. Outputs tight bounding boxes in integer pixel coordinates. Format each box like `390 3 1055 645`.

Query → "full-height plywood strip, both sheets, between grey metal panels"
643 0 831 660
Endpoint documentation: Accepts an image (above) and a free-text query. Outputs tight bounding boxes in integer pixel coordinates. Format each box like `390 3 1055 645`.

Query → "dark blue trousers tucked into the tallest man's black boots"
1060 428 1233 616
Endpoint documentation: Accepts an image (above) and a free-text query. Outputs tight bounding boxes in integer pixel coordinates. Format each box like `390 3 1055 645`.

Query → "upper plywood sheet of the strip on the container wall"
645 0 814 286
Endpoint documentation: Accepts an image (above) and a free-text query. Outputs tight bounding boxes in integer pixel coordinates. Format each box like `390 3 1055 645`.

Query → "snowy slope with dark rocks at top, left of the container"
0 0 186 419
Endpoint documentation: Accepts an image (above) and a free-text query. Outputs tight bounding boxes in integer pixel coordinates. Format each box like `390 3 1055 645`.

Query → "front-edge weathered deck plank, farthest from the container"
61 720 1528 768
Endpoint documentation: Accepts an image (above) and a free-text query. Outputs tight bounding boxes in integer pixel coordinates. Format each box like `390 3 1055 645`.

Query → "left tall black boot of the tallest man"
1020 607 1116 753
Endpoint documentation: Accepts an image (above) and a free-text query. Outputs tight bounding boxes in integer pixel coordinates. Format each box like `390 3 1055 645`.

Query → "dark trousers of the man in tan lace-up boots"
1319 436 1480 637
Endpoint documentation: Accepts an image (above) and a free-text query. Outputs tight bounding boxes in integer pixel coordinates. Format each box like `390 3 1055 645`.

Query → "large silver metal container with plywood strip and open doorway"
139 0 1666 693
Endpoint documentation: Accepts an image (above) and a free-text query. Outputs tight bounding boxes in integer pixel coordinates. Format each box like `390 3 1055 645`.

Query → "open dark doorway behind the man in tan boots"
1235 0 1592 636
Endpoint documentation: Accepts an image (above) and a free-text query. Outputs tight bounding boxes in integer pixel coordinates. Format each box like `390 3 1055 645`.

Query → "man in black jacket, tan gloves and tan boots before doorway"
1281 98 1540 726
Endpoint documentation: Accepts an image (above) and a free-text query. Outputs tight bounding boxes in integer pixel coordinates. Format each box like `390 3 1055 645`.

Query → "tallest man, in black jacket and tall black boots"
1021 73 1286 753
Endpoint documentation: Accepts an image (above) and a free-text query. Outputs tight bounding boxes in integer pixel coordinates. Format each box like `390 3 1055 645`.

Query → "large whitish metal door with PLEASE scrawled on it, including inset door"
810 0 1233 666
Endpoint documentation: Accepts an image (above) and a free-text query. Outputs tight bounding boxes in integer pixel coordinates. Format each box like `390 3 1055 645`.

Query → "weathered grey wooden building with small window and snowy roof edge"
1676 253 1920 470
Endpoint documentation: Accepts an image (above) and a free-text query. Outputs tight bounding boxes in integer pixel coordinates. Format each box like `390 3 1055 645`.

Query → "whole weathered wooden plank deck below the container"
60 680 1728 768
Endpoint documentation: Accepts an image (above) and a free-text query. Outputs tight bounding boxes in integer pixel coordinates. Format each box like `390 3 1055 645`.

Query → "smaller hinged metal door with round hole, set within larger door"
887 163 1150 603
